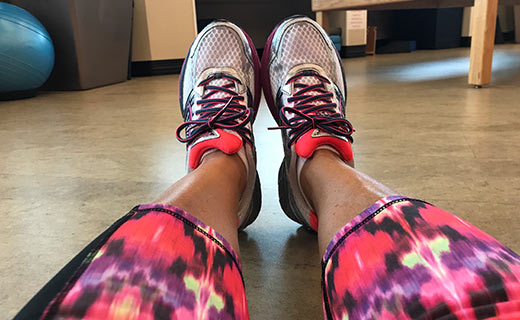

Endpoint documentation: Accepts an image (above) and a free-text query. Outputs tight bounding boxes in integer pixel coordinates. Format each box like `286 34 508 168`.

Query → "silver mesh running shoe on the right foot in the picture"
262 16 354 230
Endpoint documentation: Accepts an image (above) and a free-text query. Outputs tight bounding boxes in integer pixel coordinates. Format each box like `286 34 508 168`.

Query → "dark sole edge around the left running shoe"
179 20 262 231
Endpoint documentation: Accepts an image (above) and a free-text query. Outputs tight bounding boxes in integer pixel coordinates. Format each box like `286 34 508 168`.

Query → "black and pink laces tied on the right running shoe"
269 71 355 146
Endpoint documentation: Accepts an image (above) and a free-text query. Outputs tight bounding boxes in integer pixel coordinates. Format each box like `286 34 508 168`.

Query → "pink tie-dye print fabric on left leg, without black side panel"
43 204 248 320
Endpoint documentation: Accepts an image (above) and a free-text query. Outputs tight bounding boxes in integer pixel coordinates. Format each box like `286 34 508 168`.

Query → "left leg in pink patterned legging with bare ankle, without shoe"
17 151 248 319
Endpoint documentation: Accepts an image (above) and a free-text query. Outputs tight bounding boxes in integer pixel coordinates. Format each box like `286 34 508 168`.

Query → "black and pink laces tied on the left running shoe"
176 75 253 144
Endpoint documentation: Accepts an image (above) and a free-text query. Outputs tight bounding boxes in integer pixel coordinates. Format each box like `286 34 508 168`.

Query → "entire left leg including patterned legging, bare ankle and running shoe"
17 20 261 320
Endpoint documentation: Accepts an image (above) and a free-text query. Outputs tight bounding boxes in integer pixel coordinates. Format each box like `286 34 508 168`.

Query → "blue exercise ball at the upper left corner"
0 2 54 96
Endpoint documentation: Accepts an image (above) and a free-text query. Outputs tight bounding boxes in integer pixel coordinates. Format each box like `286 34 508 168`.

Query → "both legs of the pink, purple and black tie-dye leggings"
15 196 520 320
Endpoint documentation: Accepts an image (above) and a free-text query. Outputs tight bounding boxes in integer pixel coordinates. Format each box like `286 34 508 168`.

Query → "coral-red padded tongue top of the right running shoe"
295 129 353 162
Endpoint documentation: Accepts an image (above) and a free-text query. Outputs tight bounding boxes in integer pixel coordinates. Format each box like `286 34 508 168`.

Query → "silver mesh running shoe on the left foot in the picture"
177 20 261 229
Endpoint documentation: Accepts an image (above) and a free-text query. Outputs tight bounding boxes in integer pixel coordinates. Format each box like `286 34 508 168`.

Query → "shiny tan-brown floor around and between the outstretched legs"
0 45 520 319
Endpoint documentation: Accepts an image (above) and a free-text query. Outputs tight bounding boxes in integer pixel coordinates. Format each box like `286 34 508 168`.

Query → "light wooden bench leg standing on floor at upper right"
468 0 498 87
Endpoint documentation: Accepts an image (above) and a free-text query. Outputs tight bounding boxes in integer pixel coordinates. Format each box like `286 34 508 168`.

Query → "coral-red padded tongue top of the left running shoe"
188 129 243 170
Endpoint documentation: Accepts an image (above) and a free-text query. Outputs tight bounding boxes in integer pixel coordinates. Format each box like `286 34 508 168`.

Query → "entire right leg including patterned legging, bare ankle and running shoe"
262 16 520 320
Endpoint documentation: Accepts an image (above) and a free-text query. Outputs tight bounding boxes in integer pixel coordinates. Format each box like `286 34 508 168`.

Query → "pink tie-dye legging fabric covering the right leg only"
322 197 520 320
